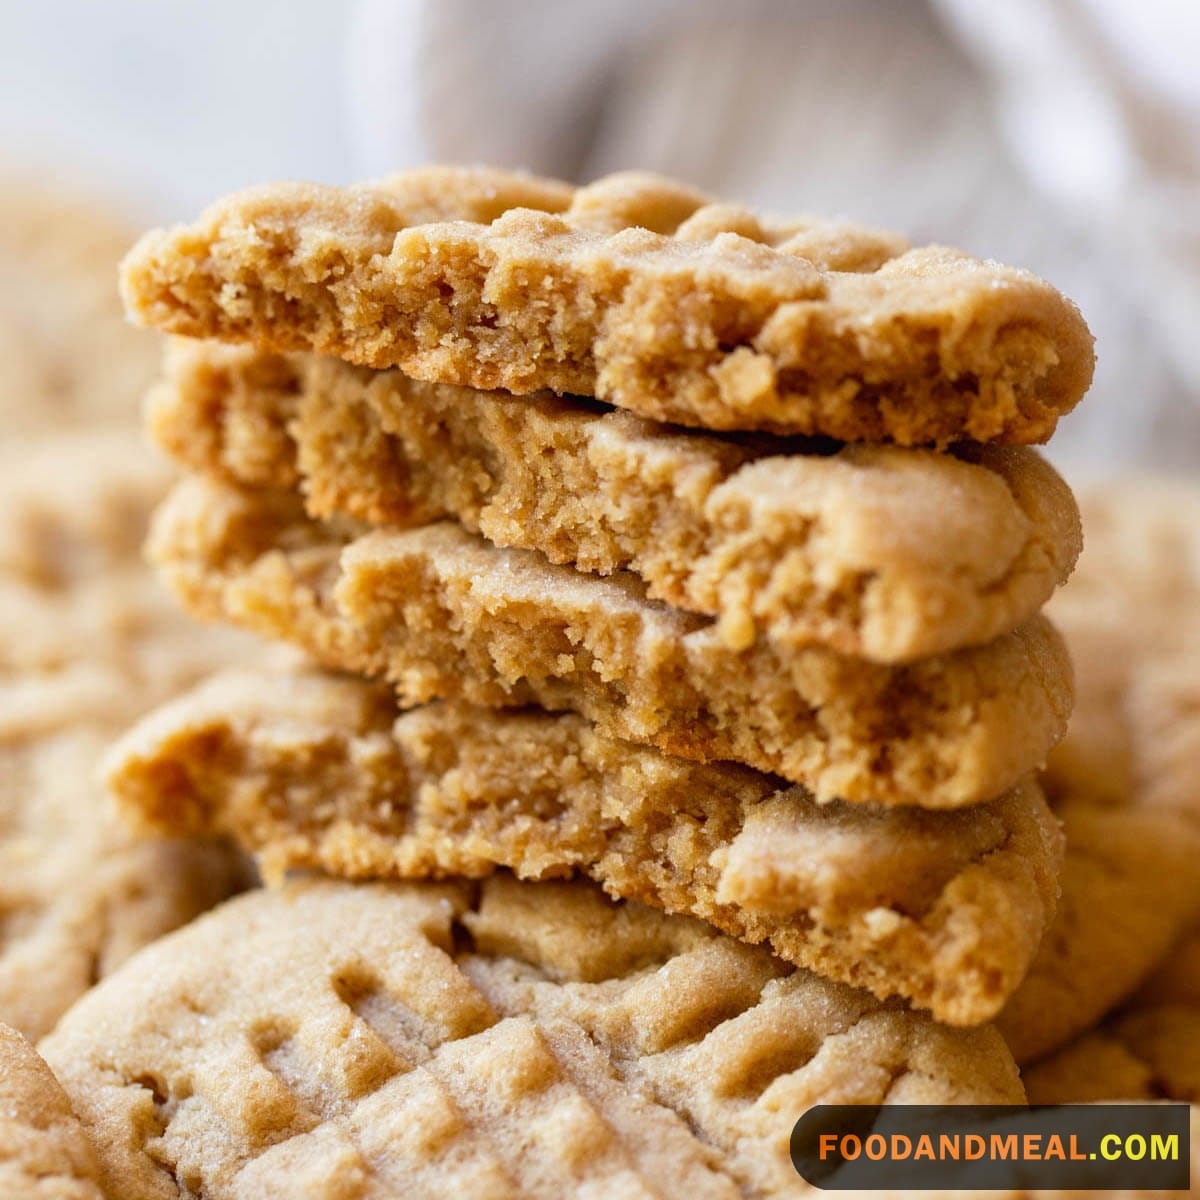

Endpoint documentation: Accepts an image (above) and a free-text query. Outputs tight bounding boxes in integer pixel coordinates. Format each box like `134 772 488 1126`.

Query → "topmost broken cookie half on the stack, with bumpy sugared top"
122 168 1093 445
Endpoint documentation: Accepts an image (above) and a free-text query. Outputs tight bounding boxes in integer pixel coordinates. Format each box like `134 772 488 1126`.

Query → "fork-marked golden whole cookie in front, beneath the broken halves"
42 877 1024 1200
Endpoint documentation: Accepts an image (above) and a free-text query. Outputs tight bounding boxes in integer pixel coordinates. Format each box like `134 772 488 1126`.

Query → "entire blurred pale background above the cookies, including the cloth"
0 0 1200 478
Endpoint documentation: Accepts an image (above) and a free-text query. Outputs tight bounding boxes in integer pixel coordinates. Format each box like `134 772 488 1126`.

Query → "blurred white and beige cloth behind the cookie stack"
349 0 1200 476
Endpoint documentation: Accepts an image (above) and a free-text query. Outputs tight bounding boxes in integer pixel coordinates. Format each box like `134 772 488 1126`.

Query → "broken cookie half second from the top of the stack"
149 341 1081 661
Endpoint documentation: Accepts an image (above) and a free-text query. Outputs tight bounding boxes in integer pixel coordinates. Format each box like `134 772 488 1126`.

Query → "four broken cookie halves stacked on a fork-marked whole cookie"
23 169 1108 1196
